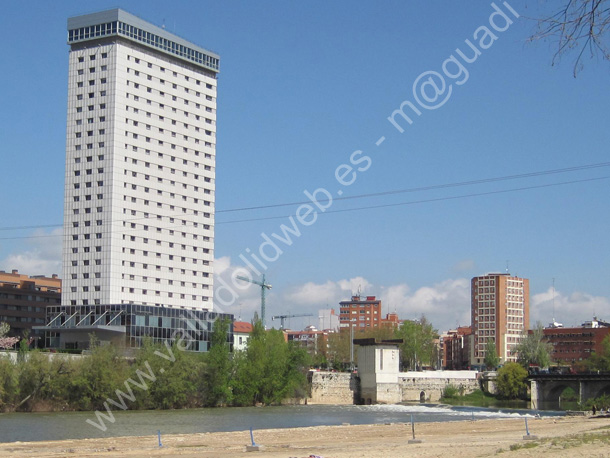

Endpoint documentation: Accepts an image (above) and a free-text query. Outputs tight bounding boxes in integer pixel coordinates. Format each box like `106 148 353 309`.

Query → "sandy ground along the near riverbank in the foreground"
0 417 610 458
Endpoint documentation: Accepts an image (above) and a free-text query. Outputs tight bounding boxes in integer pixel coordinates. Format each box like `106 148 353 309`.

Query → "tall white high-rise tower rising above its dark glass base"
62 9 219 310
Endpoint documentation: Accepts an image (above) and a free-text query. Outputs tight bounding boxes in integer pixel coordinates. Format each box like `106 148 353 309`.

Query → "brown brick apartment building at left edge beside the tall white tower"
0 270 61 343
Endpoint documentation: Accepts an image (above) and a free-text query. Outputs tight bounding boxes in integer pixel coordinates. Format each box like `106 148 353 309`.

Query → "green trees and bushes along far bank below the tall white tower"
0 320 310 411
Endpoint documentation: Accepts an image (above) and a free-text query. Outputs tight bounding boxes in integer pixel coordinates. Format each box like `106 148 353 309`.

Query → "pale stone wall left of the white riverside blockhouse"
307 371 358 404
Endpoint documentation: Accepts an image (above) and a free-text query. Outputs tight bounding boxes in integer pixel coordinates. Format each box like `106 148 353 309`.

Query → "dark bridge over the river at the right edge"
528 374 610 409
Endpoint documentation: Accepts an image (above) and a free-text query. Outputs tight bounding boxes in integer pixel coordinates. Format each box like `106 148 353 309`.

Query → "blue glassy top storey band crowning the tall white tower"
68 8 220 73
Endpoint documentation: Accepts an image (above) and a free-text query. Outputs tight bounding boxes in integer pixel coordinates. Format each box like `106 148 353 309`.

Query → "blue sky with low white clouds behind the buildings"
0 0 610 330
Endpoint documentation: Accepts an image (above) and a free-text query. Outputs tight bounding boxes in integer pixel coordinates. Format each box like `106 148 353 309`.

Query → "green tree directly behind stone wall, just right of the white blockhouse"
395 315 438 370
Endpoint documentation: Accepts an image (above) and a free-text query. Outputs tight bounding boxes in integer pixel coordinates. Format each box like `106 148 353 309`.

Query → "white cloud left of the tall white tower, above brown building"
0 228 62 276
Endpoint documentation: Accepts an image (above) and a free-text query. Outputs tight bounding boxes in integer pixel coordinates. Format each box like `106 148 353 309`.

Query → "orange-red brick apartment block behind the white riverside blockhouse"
339 296 400 330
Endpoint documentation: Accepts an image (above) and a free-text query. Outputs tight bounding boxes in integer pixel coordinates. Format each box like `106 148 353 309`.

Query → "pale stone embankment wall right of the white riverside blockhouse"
399 371 479 402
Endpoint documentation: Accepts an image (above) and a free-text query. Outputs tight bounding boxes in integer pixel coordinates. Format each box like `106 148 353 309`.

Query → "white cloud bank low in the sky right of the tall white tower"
214 257 610 332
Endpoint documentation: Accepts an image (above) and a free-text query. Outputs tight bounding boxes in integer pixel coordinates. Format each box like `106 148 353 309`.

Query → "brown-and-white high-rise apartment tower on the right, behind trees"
470 273 530 366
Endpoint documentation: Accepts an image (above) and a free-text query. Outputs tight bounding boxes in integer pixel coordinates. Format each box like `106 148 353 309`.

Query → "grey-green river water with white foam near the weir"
0 404 563 442
